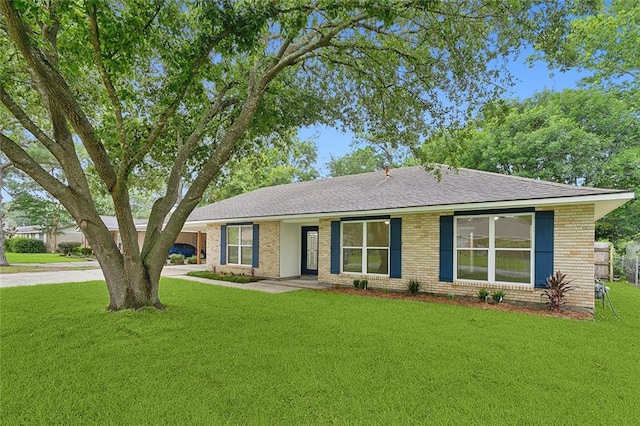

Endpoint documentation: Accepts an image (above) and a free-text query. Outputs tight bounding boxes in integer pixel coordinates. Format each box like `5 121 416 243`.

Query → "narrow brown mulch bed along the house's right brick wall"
322 287 593 320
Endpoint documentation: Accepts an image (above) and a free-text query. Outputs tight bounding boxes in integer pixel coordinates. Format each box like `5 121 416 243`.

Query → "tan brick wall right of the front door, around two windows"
318 204 595 312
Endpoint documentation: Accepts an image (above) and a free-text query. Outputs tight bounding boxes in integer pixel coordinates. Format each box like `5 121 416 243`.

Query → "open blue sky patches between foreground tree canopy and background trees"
298 51 587 175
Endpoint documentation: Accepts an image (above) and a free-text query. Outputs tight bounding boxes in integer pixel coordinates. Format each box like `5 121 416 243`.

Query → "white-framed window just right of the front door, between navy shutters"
341 219 389 275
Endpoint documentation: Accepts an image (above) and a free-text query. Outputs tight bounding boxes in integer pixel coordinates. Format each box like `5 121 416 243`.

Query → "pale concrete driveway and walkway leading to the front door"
0 263 326 293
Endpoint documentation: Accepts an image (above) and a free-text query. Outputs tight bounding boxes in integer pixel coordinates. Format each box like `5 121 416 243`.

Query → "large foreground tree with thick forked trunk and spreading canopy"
0 0 584 310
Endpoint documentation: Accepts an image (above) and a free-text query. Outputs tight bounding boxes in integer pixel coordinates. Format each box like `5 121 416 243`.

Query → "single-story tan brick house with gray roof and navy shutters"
186 167 634 311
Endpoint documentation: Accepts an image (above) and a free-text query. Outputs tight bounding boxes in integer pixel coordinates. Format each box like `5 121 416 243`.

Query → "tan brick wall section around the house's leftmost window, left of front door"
207 222 280 278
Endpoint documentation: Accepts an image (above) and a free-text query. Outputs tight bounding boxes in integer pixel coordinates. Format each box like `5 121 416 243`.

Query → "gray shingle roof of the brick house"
187 166 626 221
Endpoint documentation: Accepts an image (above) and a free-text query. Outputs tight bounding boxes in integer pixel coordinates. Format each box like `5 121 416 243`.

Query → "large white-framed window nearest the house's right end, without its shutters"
454 213 535 285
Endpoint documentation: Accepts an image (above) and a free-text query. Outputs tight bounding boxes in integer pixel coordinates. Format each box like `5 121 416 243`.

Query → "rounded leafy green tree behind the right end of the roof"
450 89 640 241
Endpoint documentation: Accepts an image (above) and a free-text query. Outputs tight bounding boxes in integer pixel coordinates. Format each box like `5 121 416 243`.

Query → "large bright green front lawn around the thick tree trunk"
0 279 640 425
